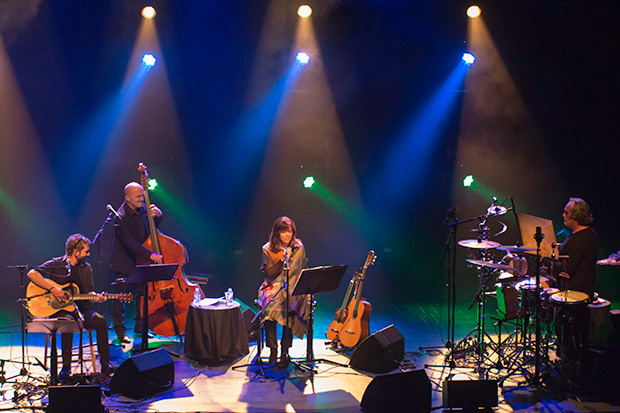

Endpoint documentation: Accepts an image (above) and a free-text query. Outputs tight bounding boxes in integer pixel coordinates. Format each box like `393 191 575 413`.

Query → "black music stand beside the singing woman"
291 265 348 367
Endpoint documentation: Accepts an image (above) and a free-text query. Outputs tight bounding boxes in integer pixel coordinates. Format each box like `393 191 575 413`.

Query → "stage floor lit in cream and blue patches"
0 304 620 413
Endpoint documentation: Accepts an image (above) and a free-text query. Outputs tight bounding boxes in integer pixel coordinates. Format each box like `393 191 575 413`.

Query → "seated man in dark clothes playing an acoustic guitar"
27 234 114 377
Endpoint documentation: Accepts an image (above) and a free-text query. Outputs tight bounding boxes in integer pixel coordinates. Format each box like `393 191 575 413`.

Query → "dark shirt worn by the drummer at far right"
560 227 598 295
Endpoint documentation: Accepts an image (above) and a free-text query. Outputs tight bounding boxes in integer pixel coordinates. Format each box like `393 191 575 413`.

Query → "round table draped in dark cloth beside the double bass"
183 301 250 364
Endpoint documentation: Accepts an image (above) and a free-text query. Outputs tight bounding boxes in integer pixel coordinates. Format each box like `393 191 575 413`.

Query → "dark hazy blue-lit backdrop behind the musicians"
0 0 620 314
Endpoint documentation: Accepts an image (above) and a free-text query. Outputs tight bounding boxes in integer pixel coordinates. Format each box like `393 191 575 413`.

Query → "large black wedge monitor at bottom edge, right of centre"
360 370 431 413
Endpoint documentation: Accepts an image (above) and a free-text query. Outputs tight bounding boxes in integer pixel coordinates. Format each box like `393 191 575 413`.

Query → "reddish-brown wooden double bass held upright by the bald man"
137 163 203 337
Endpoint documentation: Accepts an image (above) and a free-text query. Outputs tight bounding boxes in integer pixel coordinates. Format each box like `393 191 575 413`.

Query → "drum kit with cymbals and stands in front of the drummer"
450 200 602 385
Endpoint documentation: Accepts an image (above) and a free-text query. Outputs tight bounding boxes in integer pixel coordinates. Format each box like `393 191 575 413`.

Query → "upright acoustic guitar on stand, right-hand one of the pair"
338 250 376 347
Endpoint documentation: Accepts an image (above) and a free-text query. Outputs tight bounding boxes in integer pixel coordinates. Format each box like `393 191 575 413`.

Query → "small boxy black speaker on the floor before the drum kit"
442 380 498 409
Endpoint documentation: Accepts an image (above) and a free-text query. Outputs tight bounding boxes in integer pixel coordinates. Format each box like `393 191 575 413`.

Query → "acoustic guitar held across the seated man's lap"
26 279 133 317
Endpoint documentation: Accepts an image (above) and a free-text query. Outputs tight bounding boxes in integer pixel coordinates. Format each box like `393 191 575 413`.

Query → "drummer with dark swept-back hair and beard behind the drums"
556 198 598 296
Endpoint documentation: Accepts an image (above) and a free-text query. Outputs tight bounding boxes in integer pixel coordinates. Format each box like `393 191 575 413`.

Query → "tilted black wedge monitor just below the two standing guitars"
349 324 405 373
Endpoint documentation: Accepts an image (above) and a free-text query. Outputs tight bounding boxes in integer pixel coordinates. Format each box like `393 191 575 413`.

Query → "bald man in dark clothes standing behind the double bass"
112 182 162 344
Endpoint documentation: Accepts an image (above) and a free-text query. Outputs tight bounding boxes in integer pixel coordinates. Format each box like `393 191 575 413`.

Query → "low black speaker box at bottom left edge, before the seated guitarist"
47 385 103 413
